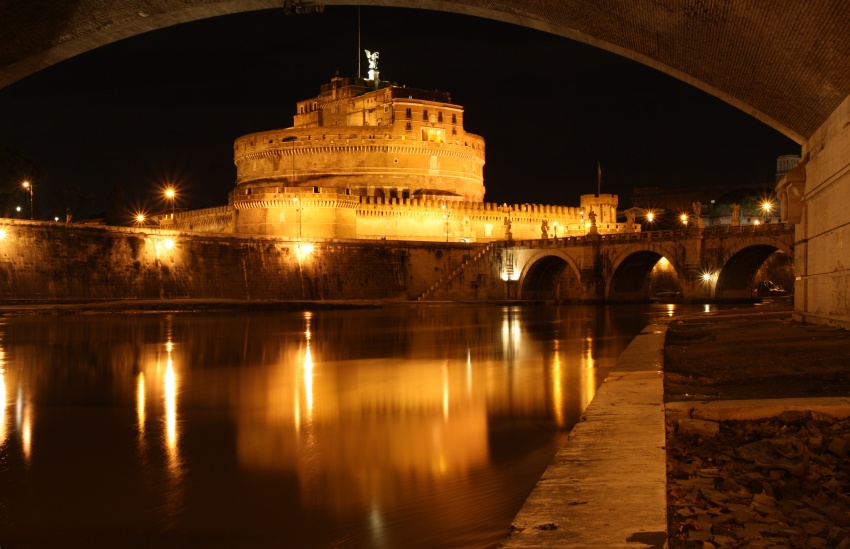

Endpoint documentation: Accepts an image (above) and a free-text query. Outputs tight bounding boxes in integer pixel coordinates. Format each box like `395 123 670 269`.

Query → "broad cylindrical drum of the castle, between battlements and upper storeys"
234 127 484 201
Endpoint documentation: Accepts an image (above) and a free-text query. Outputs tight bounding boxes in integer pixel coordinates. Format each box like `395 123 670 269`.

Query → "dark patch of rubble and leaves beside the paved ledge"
667 412 850 549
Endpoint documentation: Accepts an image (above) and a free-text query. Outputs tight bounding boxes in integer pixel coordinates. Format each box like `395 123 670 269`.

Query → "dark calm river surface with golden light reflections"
0 305 708 549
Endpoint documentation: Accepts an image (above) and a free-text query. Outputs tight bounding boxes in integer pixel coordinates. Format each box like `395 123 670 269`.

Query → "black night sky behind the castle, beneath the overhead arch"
0 6 800 219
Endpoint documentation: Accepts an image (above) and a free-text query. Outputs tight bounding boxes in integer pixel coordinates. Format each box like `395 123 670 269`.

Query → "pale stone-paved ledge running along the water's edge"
496 325 667 549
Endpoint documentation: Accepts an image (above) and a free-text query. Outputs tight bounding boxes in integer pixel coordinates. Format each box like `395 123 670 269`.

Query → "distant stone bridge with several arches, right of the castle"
491 224 794 302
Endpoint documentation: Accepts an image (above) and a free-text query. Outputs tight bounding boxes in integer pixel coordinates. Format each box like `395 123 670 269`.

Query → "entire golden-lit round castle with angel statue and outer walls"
167 51 640 242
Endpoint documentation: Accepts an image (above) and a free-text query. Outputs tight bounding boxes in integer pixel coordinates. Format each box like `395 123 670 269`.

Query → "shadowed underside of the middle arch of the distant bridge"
605 243 682 301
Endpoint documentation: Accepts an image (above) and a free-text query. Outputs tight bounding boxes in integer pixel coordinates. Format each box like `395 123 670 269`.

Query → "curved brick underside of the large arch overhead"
0 0 850 142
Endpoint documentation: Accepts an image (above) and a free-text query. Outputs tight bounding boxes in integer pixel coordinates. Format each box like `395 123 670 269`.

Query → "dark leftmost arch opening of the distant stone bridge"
518 250 582 302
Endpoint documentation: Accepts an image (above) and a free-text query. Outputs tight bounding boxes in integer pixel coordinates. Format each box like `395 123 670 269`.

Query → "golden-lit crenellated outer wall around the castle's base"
176 187 641 242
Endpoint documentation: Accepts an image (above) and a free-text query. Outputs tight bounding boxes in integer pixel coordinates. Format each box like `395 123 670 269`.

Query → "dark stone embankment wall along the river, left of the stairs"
0 220 481 301
